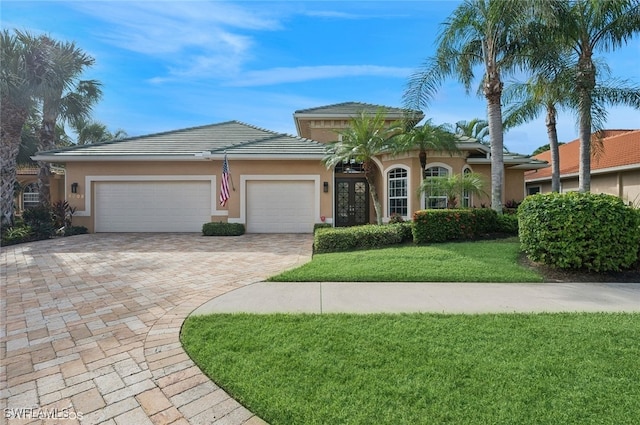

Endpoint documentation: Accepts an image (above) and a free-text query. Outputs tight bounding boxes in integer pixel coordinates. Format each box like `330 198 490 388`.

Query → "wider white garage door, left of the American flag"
95 181 211 232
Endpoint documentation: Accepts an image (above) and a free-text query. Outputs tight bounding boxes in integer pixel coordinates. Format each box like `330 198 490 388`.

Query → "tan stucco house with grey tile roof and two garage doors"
34 102 547 233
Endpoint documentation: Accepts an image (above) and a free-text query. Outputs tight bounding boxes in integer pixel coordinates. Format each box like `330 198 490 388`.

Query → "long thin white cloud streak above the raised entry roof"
227 65 411 87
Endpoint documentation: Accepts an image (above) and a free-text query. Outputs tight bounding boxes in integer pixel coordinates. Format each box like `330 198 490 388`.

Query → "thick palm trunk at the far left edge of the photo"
0 101 28 227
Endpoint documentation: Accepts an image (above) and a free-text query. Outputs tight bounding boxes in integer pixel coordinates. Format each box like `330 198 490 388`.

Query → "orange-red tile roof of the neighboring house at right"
525 130 640 180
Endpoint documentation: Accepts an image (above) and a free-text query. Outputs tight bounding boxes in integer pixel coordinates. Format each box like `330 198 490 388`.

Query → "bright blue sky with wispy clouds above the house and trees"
0 0 640 154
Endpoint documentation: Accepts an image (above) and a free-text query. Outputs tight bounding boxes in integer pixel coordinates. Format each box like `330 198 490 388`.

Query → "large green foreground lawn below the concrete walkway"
182 314 640 425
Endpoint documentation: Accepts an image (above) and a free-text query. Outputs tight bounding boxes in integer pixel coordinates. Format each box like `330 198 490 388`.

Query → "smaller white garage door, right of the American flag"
247 181 316 233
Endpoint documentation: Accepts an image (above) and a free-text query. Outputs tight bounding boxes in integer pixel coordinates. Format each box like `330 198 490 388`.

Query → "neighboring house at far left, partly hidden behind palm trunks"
15 164 64 215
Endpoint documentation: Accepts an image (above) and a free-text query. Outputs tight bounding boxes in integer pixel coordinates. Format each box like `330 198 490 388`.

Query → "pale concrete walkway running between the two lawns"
193 282 640 314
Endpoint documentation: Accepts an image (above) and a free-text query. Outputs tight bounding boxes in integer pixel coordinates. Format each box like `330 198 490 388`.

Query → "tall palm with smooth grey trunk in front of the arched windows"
404 0 530 214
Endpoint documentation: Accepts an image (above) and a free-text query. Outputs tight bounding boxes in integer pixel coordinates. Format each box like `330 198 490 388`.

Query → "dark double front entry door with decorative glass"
335 178 369 227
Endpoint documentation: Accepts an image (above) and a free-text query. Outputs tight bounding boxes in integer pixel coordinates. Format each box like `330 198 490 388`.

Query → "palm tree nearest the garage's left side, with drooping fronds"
38 36 102 204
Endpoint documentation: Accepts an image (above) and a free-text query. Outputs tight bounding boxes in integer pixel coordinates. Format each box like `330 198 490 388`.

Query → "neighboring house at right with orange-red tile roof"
525 130 640 205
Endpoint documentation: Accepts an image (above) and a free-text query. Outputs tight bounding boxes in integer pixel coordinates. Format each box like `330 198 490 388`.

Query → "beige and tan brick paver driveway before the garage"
0 234 312 425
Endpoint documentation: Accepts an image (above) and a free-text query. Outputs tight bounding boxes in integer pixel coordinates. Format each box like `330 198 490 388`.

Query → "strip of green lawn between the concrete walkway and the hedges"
269 238 543 282
